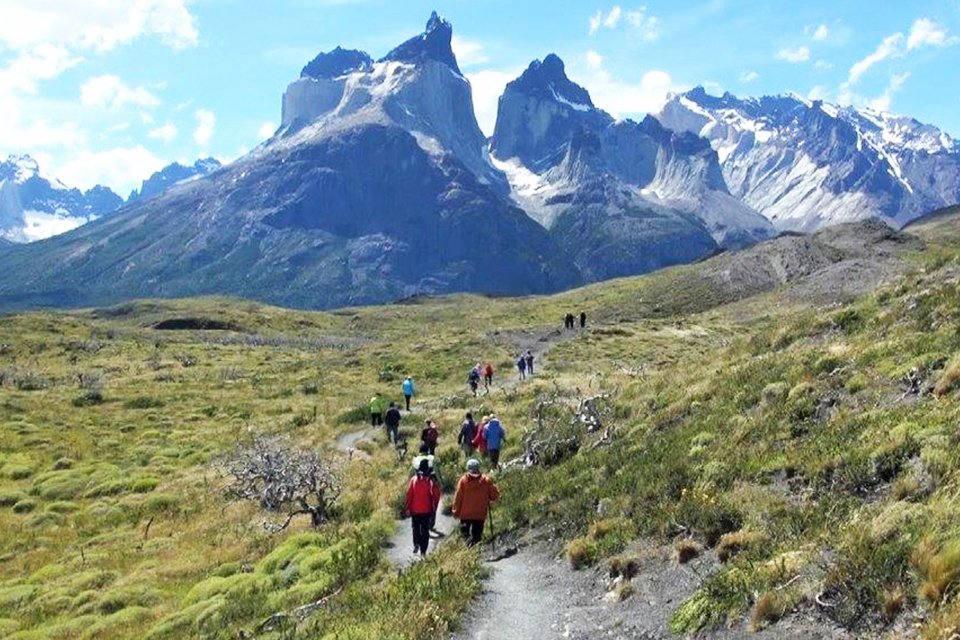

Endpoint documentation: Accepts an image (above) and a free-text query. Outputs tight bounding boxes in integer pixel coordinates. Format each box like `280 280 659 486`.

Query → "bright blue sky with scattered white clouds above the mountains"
0 0 960 196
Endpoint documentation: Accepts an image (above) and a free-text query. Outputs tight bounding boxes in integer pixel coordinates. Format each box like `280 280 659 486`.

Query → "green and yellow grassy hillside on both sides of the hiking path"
0 217 960 638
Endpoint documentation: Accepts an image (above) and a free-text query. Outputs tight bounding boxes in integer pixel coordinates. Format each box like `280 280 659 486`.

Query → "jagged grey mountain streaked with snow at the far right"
656 87 960 231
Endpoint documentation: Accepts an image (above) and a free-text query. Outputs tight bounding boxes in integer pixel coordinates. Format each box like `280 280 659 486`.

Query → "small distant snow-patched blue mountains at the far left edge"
0 155 123 242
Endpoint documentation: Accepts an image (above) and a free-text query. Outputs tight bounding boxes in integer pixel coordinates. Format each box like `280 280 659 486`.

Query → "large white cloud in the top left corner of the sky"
0 0 199 51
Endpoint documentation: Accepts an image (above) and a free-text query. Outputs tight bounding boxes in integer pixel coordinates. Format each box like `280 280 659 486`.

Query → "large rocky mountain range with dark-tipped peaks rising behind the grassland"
0 13 960 308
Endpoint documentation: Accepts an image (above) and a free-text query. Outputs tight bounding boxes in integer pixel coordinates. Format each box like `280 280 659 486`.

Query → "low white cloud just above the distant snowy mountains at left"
50 145 165 193
